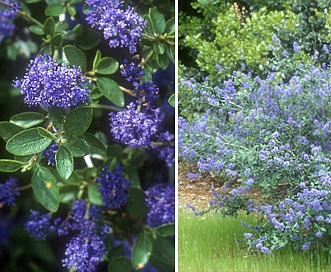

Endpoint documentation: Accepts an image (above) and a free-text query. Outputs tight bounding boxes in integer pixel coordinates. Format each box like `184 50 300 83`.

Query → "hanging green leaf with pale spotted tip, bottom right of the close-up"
131 232 154 269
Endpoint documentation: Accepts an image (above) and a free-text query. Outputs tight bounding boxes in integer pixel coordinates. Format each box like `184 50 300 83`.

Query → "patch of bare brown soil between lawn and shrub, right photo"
178 161 217 211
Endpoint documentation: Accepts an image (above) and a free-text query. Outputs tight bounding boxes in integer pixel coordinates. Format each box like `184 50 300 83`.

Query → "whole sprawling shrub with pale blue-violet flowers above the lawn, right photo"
179 37 331 253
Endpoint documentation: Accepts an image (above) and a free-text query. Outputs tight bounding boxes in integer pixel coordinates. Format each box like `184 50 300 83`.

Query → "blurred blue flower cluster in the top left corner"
0 0 20 42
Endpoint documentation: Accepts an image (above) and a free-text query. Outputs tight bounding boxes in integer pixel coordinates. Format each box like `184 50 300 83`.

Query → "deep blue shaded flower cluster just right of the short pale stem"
96 165 131 209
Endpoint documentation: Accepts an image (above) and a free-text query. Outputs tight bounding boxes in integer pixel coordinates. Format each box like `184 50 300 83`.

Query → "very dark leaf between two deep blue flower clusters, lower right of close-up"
126 187 148 219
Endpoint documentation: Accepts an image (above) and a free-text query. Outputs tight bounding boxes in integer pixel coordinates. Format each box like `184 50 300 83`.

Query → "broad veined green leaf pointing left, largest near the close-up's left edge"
6 128 52 156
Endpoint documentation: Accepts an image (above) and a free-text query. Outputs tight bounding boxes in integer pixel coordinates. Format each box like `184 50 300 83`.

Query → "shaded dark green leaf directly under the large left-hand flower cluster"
64 107 93 136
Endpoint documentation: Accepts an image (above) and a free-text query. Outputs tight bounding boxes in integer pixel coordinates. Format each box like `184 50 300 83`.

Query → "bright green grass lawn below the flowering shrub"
178 211 331 272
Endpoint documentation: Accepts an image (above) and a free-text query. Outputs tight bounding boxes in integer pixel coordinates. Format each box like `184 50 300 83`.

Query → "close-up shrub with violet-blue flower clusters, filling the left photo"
0 0 175 272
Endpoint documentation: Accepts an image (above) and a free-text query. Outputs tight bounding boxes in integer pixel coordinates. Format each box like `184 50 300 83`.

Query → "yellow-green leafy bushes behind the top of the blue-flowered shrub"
179 0 331 83
